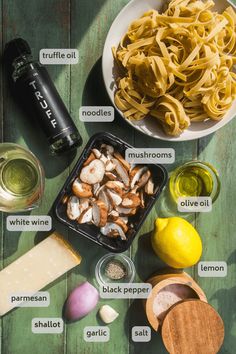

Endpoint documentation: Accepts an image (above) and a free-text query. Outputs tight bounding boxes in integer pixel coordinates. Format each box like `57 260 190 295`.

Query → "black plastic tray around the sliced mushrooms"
53 132 168 253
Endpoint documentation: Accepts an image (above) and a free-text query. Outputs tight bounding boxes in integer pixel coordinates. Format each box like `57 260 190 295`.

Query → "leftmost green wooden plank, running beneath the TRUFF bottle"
2 0 70 354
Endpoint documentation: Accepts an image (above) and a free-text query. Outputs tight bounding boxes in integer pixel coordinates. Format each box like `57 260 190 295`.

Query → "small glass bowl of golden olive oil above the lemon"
169 161 220 203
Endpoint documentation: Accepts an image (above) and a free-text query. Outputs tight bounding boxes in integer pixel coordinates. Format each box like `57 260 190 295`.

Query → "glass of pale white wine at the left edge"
0 143 44 213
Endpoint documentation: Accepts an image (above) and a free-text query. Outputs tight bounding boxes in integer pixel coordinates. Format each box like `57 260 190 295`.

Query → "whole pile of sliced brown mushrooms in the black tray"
63 144 154 240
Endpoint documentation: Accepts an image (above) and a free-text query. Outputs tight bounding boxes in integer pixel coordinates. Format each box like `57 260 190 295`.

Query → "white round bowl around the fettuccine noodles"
102 0 236 141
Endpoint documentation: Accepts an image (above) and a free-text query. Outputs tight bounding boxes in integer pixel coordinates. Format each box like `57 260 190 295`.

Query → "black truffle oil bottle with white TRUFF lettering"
5 38 82 154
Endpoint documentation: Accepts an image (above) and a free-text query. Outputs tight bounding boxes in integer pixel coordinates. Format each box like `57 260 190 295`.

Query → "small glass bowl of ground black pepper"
95 253 135 285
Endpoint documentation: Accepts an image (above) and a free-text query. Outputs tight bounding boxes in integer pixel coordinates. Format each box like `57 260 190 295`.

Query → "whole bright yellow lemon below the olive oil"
151 217 202 268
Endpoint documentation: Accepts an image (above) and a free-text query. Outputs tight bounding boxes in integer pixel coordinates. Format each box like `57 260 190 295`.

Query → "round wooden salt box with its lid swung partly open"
145 273 224 354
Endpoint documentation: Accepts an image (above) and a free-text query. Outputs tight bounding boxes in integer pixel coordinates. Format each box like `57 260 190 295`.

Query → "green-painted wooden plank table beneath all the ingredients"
0 0 236 354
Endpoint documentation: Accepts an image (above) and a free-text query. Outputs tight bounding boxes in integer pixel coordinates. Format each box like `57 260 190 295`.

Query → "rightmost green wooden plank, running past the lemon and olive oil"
197 124 236 354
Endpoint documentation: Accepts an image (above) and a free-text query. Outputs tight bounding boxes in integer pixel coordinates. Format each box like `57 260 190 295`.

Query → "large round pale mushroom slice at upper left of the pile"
80 159 105 184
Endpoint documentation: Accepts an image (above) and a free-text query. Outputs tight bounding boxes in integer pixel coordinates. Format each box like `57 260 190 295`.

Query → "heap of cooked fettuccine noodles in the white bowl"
112 0 236 136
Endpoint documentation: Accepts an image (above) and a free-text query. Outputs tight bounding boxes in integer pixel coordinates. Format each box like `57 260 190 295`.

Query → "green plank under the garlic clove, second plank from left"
67 0 132 354
